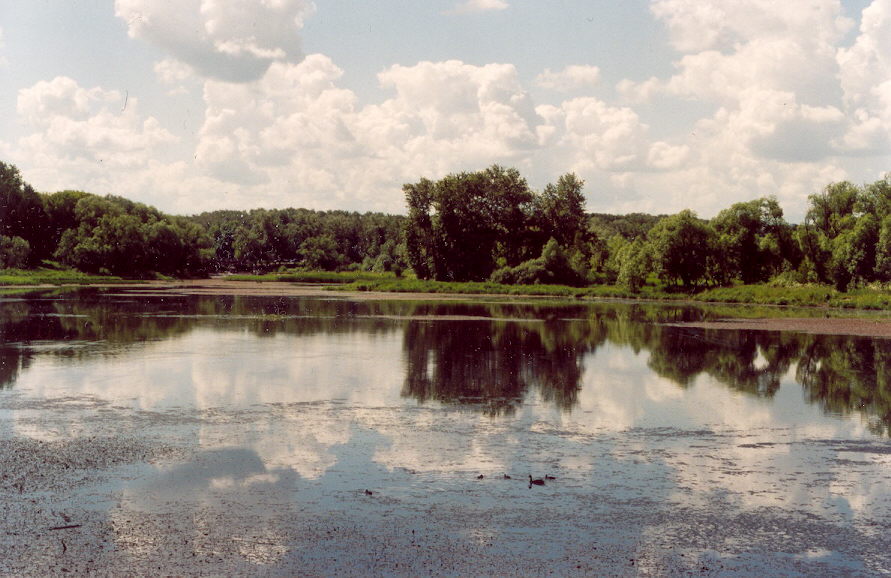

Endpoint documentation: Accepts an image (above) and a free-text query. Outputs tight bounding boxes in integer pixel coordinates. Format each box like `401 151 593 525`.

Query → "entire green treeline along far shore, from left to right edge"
0 162 891 292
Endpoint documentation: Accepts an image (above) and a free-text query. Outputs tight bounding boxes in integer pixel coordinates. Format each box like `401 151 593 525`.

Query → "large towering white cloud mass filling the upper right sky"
600 0 891 219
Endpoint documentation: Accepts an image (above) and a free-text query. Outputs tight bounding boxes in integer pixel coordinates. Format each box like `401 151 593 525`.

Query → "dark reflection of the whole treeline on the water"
0 291 891 435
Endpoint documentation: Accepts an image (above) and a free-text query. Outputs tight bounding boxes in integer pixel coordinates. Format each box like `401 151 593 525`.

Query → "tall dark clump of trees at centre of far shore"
403 165 596 282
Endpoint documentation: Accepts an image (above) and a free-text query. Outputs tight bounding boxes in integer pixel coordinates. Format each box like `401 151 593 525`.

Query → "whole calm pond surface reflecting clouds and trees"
0 290 891 575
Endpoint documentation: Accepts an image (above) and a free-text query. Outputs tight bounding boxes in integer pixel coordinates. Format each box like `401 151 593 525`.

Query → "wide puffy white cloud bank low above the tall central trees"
190 54 541 211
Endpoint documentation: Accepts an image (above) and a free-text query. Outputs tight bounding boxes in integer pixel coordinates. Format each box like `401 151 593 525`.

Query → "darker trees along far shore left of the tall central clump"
0 162 404 277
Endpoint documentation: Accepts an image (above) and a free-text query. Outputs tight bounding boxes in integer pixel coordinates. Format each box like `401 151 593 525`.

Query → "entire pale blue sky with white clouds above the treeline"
0 0 891 222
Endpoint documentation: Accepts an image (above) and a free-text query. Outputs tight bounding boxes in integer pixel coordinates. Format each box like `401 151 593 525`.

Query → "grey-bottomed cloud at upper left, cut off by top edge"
115 0 315 82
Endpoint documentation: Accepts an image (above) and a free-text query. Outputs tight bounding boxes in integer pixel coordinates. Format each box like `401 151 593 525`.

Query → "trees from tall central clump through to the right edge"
403 165 891 291
